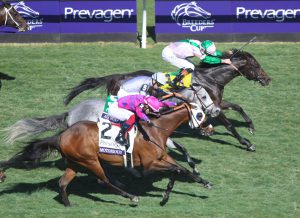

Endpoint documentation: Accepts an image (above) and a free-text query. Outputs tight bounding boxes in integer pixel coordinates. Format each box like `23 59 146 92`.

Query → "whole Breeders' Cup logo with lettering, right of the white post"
171 2 215 32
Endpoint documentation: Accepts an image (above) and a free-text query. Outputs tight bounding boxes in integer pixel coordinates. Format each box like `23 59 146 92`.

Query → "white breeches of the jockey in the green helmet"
162 47 195 70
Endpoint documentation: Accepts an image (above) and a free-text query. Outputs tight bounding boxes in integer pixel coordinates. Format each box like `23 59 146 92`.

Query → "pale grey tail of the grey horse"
1 112 68 144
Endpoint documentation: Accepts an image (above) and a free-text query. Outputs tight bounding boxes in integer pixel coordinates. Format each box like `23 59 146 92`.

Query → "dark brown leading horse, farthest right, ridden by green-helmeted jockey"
64 49 271 151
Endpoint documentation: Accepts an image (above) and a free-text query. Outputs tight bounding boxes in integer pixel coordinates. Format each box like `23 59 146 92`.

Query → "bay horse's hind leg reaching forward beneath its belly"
77 159 138 203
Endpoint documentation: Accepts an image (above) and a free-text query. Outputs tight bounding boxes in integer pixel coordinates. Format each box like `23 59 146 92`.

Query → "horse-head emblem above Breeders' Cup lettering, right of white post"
171 2 211 24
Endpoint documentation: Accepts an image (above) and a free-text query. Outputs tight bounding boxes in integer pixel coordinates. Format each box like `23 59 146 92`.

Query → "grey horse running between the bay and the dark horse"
2 73 220 174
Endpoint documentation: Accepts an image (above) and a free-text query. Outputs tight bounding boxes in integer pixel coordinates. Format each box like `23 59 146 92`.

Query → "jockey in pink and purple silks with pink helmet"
108 94 176 147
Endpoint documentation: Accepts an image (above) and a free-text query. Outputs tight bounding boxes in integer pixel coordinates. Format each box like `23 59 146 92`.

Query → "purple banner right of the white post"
155 0 300 34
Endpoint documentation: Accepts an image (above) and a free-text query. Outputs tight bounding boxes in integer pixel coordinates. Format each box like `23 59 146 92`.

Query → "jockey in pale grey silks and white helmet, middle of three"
117 72 166 98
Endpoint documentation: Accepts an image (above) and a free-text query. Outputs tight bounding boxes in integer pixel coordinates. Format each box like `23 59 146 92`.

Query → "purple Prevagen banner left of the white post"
0 0 137 35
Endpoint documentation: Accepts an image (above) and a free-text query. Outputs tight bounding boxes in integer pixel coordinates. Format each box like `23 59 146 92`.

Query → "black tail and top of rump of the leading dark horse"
64 70 153 105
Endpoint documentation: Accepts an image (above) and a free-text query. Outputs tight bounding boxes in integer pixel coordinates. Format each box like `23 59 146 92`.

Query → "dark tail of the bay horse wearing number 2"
0 134 60 170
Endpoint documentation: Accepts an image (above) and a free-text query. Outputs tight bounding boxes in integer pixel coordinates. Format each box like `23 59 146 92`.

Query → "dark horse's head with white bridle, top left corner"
0 1 28 32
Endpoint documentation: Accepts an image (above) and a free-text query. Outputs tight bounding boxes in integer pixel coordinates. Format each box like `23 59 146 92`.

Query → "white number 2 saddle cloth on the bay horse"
97 113 136 167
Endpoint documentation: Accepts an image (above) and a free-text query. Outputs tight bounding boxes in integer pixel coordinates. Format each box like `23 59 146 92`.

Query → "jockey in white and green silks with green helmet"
162 39 231 85
